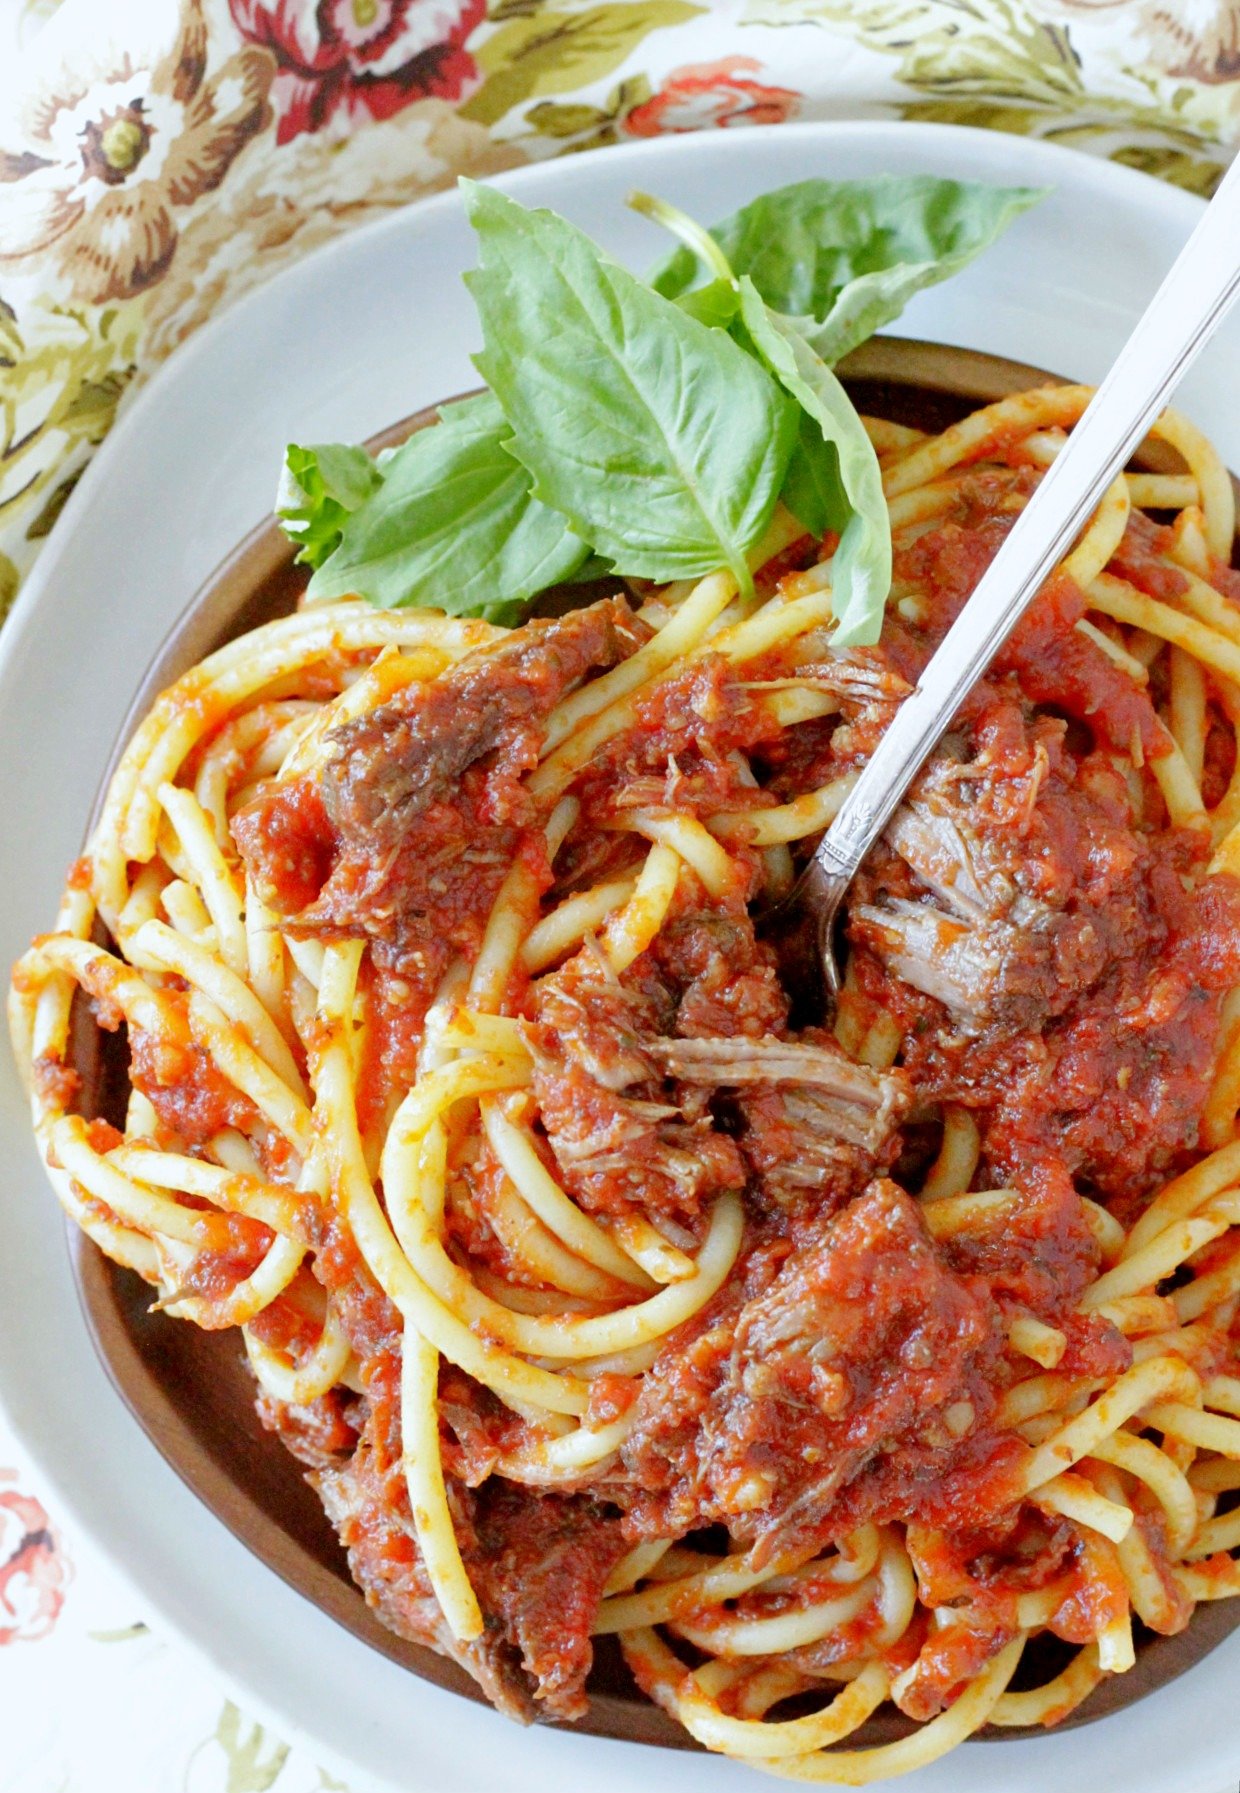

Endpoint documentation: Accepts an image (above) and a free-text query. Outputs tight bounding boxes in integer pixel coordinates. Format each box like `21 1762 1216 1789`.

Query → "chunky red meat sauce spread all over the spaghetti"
79 468 1240 1719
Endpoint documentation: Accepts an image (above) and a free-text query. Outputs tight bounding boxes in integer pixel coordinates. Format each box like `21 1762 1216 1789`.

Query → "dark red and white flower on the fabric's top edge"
228 0 486 143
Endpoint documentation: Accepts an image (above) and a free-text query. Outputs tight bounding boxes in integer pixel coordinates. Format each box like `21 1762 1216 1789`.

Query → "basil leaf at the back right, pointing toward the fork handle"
652 174 1046 362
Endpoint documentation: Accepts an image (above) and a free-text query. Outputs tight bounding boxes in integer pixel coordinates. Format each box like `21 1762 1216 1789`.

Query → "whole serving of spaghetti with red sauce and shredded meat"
11 385 1240 1786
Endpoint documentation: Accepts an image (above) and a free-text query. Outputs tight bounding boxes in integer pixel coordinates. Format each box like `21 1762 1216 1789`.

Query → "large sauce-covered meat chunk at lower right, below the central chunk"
622 1182 1007 1563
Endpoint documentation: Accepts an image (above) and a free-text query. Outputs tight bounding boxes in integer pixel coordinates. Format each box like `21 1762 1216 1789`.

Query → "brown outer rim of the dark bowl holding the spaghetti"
66 335 1240 1750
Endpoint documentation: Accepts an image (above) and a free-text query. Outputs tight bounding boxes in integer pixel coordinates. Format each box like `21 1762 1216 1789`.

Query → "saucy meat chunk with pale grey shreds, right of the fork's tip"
849 690 1240 1216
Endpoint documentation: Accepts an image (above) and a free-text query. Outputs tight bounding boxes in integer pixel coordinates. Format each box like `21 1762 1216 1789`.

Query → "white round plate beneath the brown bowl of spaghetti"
0 124 1240 1793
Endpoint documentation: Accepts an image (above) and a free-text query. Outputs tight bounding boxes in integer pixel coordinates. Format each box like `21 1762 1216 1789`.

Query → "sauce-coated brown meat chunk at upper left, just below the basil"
231 601 640 988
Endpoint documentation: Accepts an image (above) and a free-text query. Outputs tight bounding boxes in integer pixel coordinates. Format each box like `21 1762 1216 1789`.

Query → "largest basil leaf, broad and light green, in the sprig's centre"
461 181 796 588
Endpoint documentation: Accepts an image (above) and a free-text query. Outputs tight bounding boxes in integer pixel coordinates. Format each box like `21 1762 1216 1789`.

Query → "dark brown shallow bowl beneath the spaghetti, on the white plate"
70 337 1240 1748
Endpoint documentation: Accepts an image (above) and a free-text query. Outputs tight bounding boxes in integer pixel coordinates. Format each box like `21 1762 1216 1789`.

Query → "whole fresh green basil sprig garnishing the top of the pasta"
278 178 1039 631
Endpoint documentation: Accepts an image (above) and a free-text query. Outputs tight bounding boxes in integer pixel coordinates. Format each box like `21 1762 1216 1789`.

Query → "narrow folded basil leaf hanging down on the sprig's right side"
738 274 891 647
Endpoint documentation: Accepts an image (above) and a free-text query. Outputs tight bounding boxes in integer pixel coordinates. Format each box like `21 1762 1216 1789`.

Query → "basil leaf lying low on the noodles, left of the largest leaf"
308 393 590 624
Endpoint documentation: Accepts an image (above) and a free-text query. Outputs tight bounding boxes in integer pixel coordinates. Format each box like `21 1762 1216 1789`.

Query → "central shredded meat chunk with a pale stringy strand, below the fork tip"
527 916 907 1221
